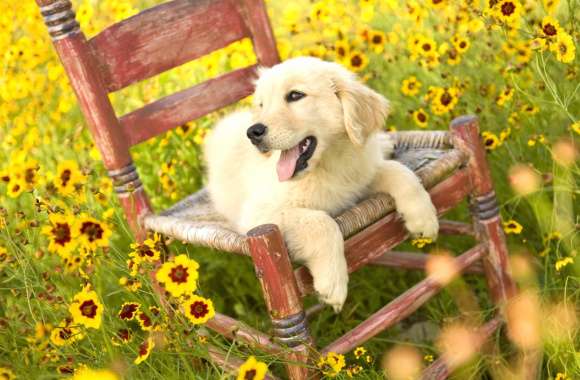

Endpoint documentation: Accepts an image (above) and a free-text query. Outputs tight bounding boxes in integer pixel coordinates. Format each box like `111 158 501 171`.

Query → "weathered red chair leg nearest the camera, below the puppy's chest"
247 224 313 380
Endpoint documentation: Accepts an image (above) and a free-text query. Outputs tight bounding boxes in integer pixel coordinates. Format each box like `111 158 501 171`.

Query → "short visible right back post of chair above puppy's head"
241 0 280 67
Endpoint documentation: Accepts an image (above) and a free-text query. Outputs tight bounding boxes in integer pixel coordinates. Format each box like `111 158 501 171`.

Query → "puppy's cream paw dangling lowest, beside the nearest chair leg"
312 265 348 313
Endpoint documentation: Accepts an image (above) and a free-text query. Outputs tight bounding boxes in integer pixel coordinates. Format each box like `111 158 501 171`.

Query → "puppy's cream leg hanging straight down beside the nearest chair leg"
278 208 348 312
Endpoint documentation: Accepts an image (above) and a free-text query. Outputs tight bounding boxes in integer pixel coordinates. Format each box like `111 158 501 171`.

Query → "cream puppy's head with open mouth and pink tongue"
247 57 389 181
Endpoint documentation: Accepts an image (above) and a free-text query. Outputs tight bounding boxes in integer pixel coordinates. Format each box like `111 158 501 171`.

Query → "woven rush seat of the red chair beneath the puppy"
143 131 466 255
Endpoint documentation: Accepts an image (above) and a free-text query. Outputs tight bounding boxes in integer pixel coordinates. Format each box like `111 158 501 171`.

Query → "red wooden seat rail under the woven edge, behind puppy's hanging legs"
294 169 471 295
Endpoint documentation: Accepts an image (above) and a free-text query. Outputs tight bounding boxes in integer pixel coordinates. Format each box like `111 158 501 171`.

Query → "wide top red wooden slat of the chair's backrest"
89 0 249 92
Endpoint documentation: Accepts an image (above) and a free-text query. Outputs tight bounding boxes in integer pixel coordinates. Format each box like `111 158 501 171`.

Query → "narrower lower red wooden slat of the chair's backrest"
120 66 256 146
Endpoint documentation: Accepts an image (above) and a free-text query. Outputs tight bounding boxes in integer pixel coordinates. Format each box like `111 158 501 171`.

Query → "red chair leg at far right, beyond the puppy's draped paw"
451 116 515 306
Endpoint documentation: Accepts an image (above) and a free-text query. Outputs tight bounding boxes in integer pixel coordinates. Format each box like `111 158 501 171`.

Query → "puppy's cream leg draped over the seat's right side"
372 161 439 238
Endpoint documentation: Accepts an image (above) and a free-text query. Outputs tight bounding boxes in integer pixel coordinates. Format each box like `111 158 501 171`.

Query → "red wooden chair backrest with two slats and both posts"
36 0 279 238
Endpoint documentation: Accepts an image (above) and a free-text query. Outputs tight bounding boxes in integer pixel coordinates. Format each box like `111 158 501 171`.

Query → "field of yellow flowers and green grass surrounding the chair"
0 0 580 380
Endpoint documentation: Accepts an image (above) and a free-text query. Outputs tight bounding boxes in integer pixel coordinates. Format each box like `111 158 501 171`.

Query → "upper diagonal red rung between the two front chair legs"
322 244 487 353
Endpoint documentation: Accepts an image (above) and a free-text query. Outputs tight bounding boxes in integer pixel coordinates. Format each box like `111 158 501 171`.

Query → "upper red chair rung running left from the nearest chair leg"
206 313 284 354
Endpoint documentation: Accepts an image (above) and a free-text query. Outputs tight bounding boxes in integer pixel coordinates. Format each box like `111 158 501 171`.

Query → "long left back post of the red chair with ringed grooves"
36 0 151 239
